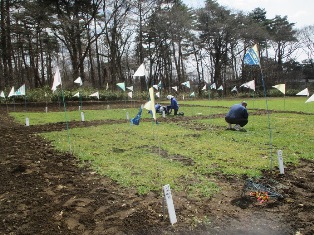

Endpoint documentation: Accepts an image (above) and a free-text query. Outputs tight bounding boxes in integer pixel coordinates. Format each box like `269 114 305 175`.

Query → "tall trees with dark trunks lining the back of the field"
0 0 314 100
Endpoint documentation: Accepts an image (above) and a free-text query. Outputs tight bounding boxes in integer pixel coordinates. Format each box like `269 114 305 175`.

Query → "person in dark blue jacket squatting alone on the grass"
225 101 249 130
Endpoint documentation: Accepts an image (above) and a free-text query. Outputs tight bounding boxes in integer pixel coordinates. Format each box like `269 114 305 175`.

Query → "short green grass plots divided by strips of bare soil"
11 97 314 198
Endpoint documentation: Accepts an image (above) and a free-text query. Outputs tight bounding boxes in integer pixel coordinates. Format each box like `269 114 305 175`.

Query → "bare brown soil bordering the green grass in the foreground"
0 103 314 235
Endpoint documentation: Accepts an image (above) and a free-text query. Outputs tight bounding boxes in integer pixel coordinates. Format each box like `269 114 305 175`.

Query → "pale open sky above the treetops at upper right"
183 0 314 28
